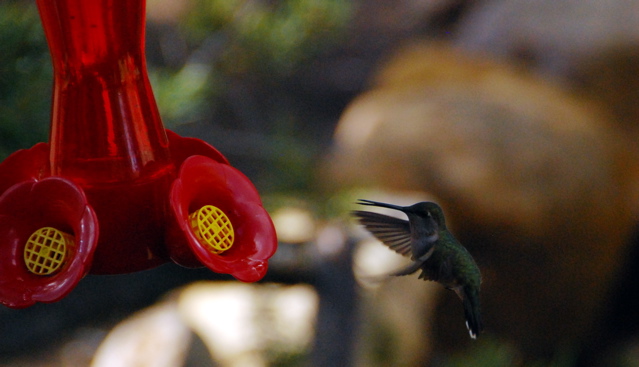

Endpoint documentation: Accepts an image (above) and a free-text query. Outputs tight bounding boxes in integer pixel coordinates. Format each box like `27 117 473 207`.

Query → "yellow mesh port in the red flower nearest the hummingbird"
189 205 235 254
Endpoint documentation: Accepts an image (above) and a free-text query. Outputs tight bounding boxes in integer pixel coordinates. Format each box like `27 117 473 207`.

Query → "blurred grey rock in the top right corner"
455 0 639 76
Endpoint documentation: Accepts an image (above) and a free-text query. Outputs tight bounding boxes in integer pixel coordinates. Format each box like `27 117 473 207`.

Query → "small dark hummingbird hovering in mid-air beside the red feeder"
353 199 483 339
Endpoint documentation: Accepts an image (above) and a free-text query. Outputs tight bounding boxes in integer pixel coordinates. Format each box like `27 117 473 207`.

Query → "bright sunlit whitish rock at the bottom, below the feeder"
91 281 319 367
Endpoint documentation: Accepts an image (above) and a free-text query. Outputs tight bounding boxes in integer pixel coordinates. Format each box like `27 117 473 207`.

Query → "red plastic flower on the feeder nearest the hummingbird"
169 155 277 282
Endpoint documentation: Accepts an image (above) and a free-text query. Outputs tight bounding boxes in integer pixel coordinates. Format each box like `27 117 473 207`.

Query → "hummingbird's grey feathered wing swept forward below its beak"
353 210 411 256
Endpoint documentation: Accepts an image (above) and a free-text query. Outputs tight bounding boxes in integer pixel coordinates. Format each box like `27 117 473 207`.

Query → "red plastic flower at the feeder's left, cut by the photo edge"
0 177 98 308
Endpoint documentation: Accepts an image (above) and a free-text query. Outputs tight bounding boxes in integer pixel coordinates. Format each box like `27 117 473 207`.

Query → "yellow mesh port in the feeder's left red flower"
24 227 75 275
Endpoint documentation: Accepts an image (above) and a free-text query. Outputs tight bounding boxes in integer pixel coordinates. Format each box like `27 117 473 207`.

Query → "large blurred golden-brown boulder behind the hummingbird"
324 44 638 359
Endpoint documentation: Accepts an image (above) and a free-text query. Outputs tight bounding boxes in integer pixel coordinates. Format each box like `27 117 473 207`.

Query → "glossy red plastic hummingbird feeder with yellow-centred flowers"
0 0 277 308
